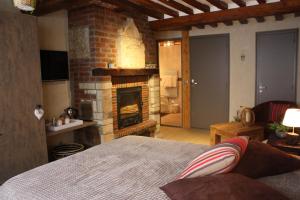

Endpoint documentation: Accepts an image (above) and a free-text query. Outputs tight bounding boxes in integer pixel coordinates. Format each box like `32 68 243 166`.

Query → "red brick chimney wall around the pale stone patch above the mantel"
69 6 157 107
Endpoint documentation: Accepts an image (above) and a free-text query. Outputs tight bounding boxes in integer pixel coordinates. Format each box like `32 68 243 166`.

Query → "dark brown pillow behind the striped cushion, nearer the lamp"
232 141 300 178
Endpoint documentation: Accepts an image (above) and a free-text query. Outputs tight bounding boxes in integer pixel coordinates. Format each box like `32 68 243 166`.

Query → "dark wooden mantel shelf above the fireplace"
92 68 159 76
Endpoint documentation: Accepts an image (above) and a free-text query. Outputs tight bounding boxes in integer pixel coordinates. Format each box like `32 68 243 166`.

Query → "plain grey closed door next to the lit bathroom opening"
190 34 229 129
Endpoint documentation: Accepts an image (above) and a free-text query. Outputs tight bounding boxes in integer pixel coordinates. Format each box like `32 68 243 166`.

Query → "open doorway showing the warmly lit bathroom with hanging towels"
158 40 182 127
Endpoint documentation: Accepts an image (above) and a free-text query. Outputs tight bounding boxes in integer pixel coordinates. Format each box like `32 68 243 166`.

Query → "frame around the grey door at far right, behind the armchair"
254 28 299 105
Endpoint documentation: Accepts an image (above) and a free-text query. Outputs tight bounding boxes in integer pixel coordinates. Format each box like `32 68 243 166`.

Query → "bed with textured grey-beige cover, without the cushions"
0 136 300 200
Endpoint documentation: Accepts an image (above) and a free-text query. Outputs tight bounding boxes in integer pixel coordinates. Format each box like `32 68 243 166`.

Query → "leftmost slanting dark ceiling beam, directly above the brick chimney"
102 0 164 19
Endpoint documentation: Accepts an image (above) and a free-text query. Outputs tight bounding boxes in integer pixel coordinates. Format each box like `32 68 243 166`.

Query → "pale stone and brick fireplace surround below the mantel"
79 75 160 142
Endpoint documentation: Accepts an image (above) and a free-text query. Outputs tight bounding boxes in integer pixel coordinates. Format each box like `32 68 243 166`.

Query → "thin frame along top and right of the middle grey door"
189 33 231 126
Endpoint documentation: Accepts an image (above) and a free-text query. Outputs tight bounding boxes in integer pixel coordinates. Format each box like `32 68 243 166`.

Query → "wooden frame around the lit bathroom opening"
156 37 185 128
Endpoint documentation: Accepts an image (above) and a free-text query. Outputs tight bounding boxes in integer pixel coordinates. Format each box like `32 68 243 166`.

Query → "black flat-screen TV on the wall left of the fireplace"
40 50 69 81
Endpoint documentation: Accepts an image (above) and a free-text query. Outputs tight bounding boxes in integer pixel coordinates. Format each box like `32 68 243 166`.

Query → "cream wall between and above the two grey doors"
157 14 300 120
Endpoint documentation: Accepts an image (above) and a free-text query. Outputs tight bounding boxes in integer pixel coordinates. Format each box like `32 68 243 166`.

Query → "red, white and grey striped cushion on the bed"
177 136 248 179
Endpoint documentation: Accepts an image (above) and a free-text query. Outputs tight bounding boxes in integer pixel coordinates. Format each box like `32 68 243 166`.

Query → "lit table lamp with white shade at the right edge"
282 108 300 144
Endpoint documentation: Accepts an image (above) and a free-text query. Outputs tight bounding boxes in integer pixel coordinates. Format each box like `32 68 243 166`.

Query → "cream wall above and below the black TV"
38 11 71 119
